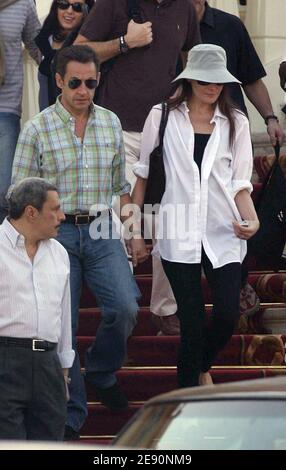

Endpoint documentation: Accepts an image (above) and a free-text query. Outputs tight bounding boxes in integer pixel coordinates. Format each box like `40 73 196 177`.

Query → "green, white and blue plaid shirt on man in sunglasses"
12 99 130 214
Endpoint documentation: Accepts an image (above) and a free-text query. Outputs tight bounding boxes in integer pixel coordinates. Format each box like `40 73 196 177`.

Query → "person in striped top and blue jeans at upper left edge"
0 0 41 223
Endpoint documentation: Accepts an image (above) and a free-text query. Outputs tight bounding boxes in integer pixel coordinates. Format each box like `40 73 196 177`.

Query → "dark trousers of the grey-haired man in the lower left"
0 344 66 441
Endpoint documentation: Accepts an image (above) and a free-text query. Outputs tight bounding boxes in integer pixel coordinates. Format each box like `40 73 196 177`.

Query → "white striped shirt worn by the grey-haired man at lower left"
0 219 74 368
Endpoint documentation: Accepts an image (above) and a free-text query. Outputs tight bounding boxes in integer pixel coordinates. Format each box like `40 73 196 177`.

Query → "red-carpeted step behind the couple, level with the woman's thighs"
80 272 286 308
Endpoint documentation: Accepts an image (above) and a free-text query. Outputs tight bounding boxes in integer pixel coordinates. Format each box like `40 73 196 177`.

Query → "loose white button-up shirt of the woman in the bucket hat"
133 103 253 268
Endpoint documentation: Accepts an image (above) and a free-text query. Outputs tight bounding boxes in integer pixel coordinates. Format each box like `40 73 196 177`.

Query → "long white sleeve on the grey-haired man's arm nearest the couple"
57 255 75 369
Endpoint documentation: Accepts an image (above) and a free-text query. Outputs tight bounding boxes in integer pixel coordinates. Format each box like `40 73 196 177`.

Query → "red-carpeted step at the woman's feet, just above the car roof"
86 367 286 402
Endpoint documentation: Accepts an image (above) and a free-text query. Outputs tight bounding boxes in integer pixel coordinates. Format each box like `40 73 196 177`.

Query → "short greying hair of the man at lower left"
7 178 57 220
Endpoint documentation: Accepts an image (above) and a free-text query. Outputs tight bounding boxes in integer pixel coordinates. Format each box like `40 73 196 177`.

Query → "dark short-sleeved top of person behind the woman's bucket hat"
200 3 266 113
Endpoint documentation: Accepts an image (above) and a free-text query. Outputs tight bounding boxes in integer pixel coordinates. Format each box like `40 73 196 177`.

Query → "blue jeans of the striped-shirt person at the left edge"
0 113 20 224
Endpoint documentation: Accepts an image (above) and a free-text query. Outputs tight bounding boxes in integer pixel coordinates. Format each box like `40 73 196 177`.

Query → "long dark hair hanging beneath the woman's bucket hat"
167 80 238 147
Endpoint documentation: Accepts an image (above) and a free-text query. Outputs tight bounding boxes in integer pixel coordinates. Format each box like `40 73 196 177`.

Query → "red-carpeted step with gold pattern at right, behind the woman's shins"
78 335 286 366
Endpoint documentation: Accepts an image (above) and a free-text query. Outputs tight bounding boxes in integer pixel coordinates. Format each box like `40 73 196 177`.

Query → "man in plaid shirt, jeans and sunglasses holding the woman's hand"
12 46 148 439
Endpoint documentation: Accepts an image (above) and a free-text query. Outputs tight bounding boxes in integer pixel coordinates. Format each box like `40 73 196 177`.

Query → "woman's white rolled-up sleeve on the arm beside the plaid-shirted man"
132 105 162 179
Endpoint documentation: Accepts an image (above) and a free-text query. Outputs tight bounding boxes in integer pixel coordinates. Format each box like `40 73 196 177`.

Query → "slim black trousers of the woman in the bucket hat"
162 252 241 387
